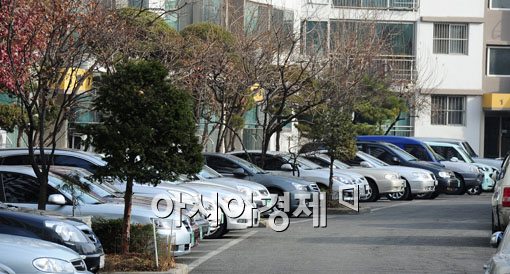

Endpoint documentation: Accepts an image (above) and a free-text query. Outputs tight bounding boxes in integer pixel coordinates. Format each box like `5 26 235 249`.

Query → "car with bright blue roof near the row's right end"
358 135 483 195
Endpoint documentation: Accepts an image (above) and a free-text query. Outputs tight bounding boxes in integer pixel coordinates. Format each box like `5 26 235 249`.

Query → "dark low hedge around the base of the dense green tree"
92 218 154 254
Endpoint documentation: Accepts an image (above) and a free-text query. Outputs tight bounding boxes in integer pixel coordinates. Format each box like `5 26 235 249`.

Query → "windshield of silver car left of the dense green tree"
48 174 103 204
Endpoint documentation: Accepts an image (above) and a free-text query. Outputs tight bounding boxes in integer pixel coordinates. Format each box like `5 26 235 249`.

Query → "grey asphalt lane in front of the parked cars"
176 193 495 273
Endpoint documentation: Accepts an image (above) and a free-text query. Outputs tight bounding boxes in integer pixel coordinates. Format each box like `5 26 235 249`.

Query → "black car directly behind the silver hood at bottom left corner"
0 203 104 272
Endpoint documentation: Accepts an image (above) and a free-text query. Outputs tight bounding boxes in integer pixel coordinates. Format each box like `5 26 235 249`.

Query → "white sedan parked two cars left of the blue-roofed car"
304 153 436 200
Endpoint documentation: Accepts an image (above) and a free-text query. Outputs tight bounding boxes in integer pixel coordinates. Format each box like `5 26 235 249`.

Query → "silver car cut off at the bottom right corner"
483 226 510 274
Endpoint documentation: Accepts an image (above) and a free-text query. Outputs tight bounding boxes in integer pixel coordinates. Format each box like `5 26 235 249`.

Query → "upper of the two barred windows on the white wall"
434 23 468 55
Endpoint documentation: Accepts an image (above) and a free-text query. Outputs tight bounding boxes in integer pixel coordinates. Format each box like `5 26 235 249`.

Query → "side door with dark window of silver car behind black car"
0 172 71 214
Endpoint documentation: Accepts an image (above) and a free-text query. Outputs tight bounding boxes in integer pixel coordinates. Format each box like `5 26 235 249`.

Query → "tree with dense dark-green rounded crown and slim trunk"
86 60 203 253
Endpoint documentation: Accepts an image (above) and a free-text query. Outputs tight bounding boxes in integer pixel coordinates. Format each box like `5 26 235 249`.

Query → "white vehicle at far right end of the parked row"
425 141 499 195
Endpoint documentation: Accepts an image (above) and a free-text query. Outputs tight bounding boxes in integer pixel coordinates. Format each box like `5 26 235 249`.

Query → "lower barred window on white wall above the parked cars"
431 95 466 125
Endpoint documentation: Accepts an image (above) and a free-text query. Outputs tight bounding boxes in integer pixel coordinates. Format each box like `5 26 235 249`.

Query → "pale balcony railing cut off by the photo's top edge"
332 0 418 11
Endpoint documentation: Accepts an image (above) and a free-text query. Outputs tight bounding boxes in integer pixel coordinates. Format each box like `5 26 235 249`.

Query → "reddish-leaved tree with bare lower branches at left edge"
0 0 120 209
